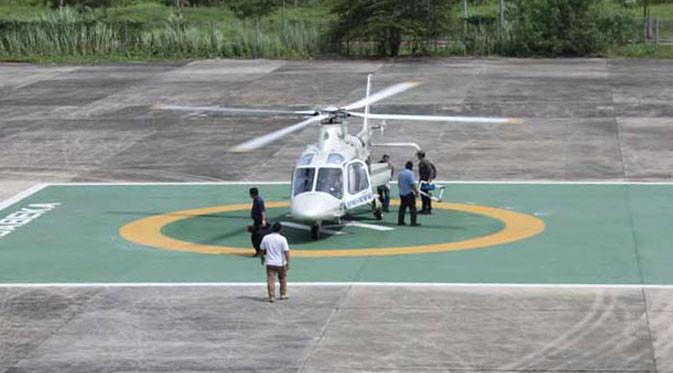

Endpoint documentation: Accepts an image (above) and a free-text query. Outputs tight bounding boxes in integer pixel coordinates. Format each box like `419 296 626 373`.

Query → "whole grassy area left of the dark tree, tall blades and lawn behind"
0 0 328 62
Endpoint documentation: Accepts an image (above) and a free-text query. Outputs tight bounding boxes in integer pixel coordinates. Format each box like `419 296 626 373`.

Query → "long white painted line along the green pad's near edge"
0 282 673 290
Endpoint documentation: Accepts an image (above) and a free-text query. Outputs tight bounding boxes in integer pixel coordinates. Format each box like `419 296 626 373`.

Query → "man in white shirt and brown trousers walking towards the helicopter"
260 222 290 303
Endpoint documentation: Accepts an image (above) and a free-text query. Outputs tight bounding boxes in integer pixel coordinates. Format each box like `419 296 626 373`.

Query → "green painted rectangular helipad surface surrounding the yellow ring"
0 183 673 284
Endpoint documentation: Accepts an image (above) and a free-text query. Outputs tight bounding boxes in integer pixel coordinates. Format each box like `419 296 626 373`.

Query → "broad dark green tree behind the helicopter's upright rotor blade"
332 0 453 57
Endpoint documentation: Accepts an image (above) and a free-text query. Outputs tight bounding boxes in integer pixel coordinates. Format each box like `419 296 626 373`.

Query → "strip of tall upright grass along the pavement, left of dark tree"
0 8 326 59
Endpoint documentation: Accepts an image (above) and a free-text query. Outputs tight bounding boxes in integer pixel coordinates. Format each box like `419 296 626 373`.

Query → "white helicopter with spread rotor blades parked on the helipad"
154 74 520 239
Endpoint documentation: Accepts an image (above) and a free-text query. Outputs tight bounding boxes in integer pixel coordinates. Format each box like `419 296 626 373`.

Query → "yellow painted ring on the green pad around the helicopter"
119 201 545 257
